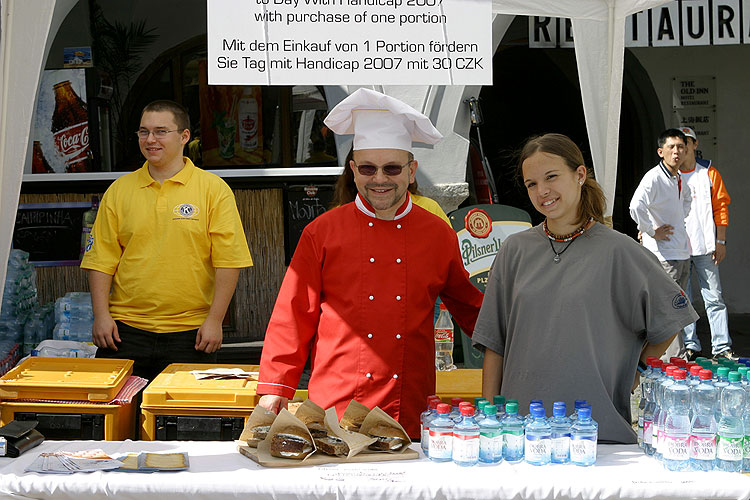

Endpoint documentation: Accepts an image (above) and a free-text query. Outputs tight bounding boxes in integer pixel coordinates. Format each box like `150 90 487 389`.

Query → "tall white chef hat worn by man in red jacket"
324 88 443 151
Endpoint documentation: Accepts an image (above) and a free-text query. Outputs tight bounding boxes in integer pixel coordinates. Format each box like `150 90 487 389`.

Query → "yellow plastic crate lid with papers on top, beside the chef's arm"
141 363 259 409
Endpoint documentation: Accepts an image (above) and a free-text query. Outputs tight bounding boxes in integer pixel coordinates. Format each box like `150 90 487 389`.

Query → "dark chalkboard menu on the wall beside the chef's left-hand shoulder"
284 184 333 265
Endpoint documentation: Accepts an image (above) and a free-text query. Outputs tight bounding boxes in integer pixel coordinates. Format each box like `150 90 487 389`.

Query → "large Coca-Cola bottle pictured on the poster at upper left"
52 80 90 172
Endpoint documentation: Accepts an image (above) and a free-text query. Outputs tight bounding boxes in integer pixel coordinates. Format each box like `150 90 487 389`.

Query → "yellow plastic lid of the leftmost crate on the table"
0 357 133 401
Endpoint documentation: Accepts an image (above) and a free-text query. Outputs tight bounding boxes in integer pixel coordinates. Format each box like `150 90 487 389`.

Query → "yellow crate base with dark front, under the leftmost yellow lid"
0 401 136 441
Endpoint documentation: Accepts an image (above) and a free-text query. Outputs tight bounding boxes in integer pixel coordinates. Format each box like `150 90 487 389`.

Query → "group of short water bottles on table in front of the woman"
421 396 598 466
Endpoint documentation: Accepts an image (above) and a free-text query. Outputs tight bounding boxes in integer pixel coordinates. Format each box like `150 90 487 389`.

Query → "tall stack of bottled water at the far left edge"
0 248 38 359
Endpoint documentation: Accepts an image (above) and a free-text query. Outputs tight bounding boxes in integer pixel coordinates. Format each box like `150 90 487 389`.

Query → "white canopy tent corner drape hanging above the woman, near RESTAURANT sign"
492 0 668 216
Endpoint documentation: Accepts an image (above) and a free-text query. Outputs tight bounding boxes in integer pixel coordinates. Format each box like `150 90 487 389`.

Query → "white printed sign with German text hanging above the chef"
207 0 492 85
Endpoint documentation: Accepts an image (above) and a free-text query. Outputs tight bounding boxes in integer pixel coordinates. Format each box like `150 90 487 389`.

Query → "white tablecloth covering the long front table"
0 441 750 500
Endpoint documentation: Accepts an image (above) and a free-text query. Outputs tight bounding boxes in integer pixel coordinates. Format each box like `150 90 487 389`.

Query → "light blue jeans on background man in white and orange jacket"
683 254 732 354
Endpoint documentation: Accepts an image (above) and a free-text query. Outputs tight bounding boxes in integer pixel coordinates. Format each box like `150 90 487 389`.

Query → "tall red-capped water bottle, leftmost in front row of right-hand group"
663 370 690 470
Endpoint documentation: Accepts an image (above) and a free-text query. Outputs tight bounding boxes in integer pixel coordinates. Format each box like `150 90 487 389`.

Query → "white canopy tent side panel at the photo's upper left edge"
0 0 77 299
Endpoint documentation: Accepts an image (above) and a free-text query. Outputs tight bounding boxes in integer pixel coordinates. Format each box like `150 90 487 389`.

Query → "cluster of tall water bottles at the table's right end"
638 358 750 472
